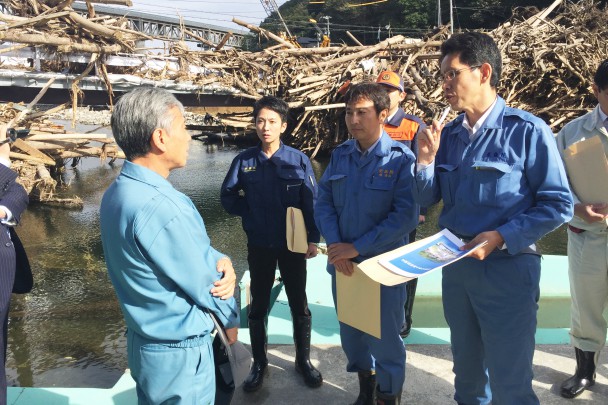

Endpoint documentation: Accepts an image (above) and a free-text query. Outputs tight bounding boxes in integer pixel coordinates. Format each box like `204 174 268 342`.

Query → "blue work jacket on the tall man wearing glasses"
414 97 573 254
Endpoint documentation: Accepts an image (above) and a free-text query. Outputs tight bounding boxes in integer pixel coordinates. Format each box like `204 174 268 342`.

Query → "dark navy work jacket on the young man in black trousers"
221 142 320 248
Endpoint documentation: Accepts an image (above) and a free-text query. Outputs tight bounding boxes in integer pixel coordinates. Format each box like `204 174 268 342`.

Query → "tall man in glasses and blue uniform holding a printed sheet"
414 32 573 405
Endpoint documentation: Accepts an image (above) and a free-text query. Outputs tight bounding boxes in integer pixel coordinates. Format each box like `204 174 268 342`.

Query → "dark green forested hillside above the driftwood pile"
261 0 564 45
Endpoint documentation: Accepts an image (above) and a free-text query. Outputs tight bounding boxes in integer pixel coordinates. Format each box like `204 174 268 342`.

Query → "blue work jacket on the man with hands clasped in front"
315 131 418 266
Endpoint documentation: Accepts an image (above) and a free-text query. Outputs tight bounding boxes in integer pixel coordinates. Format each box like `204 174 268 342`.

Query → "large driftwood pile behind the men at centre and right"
166 0 608 155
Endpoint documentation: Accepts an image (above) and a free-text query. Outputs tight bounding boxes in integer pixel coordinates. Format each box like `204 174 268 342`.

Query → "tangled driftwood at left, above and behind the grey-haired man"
0 0 134 202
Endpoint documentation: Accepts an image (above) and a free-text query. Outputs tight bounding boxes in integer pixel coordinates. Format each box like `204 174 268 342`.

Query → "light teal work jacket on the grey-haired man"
100 161 239 341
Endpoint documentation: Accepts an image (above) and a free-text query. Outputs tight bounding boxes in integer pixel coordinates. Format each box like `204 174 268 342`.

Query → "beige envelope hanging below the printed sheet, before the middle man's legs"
336 265 381 339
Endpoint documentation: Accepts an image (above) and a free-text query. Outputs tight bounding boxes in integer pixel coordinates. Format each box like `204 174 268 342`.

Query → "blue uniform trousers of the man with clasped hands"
331 274 406 395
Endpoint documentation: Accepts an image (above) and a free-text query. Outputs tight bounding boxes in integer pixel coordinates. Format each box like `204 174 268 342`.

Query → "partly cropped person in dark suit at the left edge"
0 125 29 405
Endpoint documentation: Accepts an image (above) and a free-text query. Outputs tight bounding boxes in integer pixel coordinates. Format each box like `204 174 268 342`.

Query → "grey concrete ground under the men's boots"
232 345 608 405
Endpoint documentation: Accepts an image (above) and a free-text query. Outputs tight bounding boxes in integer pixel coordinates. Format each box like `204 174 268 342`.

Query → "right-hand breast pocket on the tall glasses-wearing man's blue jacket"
472 161 519 207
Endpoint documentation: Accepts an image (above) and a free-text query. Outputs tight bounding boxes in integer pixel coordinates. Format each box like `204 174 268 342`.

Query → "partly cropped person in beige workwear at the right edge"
556 59 608 398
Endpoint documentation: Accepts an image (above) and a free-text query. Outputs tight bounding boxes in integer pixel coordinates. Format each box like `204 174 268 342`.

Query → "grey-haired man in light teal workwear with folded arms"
100 88 239 405
